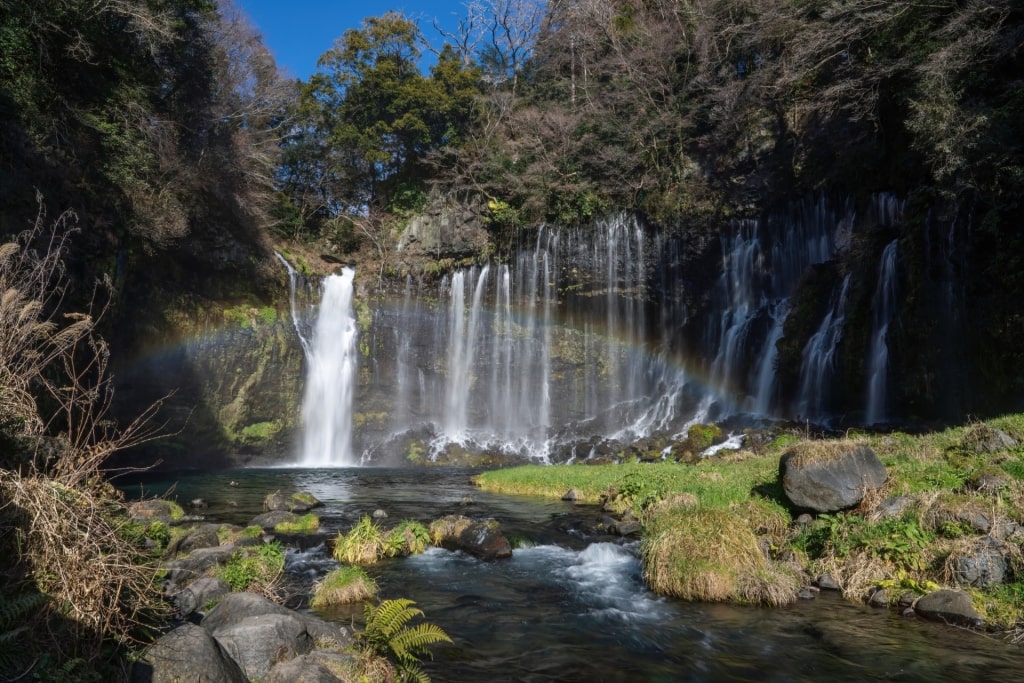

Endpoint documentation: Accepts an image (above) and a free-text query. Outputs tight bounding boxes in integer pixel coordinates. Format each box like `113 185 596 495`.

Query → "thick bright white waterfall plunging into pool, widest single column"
300 268 357 467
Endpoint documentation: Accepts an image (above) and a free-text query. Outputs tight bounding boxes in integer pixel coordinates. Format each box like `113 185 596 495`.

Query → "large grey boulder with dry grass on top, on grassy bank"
779 441 888 513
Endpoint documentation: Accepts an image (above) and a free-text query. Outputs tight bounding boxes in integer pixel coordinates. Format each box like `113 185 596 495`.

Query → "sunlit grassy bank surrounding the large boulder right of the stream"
474 415 1024 626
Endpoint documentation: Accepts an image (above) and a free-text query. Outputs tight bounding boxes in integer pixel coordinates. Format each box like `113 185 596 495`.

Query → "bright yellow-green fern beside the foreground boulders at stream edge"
358 598 452 683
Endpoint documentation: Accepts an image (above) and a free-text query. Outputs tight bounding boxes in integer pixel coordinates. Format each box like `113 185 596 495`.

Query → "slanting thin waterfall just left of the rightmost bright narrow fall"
797 274 850 421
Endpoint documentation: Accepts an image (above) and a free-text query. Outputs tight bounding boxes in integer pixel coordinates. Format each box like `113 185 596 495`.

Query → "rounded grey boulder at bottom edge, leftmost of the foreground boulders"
131 624 247 683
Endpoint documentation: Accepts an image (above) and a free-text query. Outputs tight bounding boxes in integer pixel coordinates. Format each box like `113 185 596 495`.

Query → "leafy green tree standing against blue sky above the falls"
279 12 479 240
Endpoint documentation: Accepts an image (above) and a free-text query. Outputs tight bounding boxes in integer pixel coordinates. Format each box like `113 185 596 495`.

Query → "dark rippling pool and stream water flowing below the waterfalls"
122 468 1024 682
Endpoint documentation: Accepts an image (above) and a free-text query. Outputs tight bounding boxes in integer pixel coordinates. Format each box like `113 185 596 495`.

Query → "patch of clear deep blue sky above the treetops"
236 0 465 79
